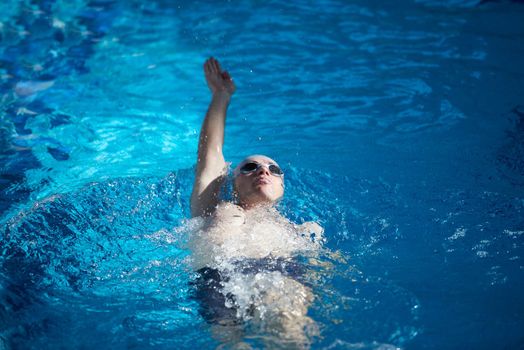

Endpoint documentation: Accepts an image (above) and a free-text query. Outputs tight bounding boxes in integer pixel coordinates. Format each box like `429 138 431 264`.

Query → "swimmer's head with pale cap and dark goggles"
234 155 284 208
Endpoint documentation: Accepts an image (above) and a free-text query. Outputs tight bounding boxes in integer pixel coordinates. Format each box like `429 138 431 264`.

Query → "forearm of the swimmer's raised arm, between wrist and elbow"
198 92 231 163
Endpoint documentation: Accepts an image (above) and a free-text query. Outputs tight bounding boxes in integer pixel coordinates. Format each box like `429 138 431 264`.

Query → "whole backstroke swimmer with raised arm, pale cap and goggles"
190 57 323 348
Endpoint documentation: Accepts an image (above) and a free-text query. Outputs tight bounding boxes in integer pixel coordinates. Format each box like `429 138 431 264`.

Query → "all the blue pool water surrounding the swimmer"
0 0 524 349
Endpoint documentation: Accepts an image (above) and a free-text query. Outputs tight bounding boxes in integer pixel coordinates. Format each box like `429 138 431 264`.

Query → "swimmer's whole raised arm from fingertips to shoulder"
191 57 235 217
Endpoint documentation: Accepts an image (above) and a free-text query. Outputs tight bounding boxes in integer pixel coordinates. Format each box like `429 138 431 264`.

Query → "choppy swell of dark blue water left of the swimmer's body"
2 174 205 348
